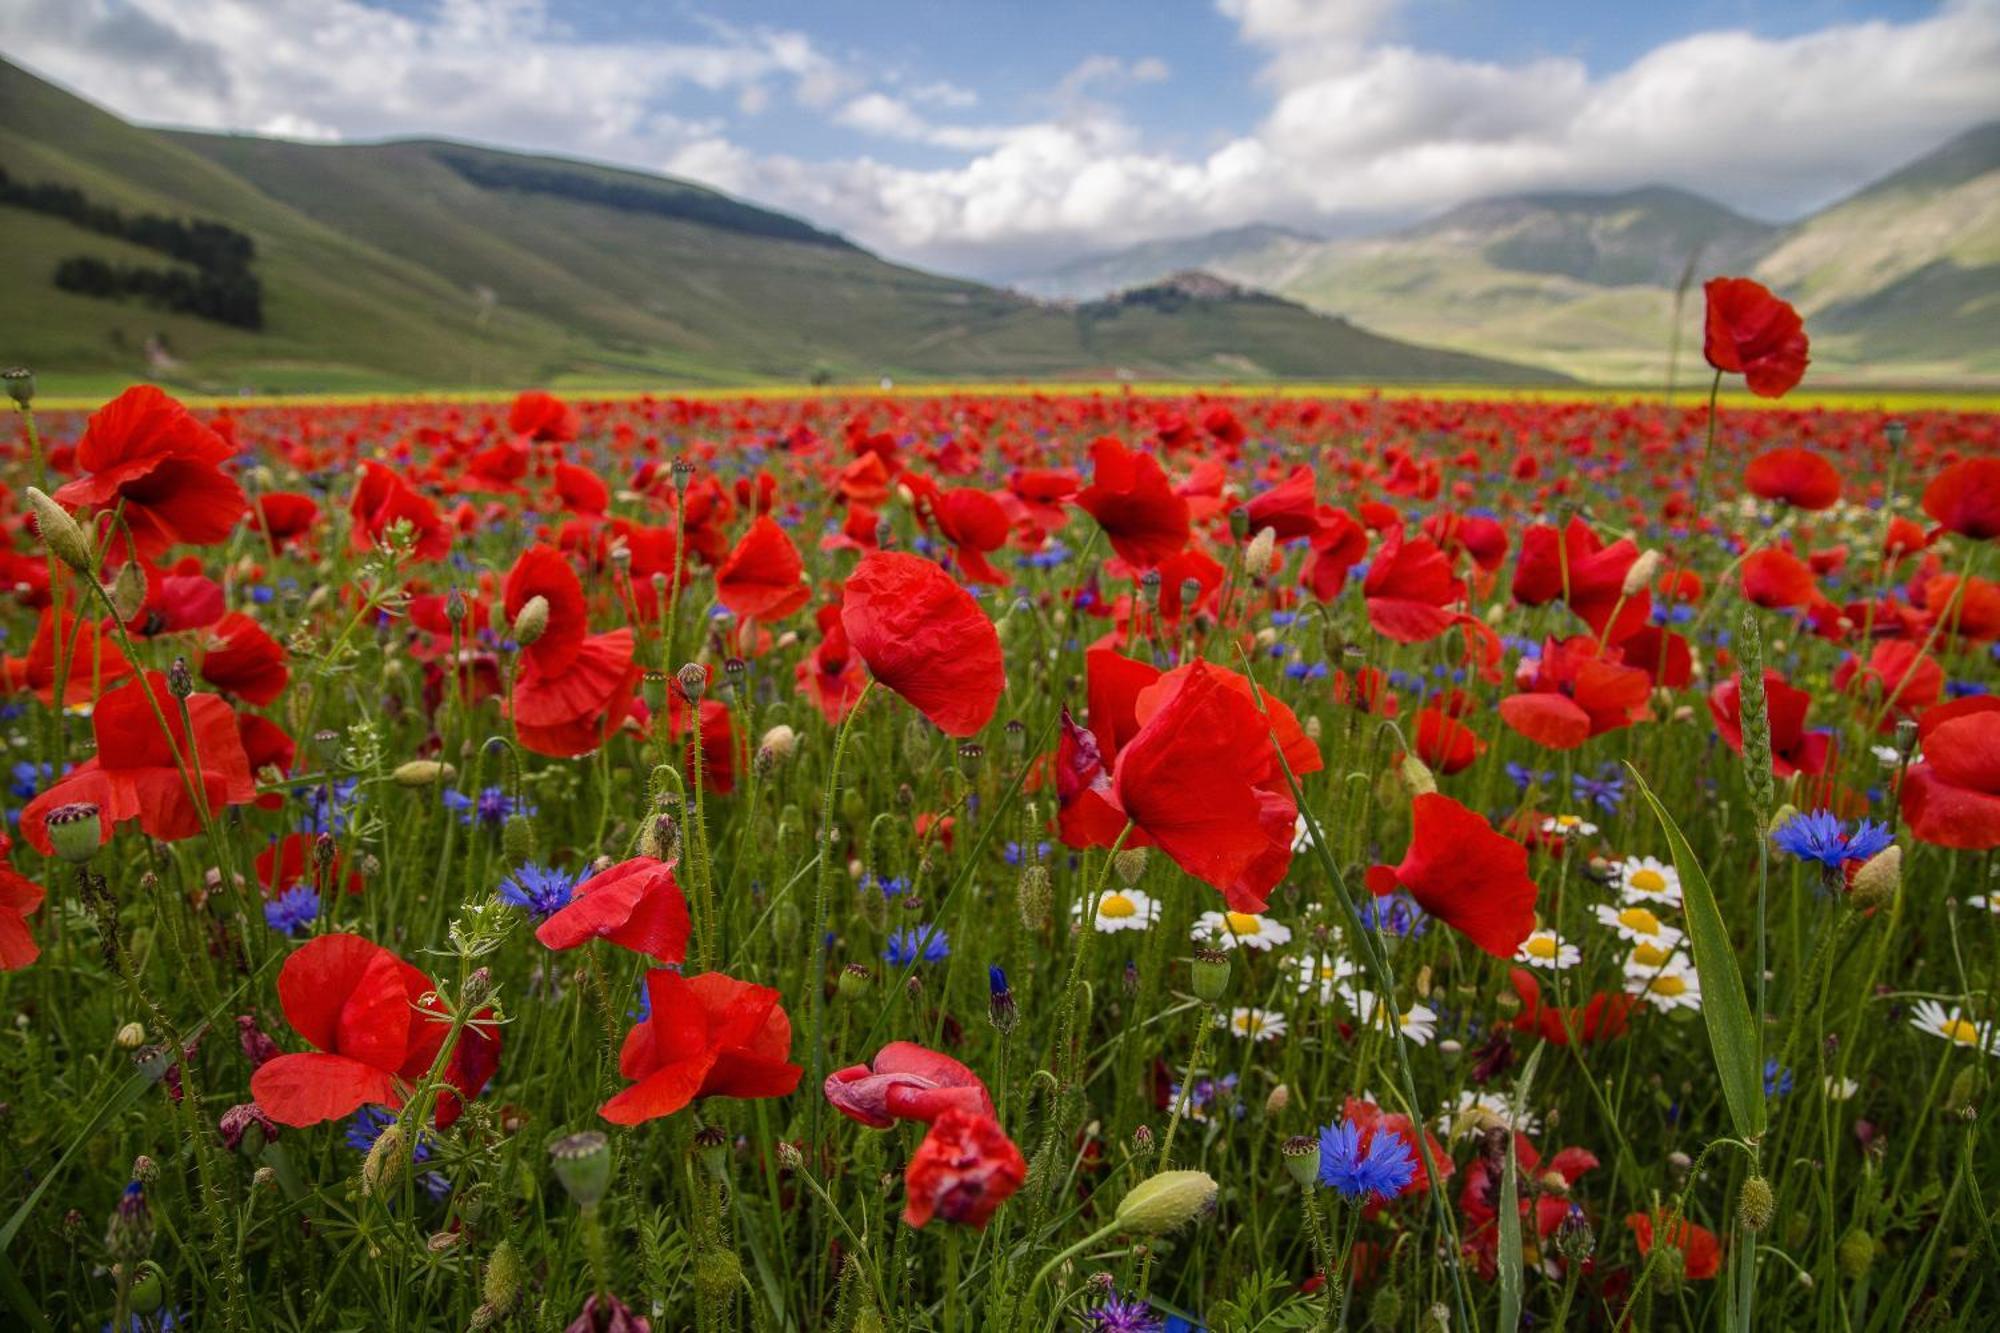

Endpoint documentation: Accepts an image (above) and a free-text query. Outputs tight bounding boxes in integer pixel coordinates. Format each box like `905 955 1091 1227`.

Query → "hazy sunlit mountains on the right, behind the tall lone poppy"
1024 122 2000 384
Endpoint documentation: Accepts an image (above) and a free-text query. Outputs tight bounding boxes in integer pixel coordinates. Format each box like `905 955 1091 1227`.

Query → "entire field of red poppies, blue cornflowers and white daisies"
0 280 2000 1333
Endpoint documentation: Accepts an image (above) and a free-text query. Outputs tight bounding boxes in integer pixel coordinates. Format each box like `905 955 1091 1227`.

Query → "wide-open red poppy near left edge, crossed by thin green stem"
20 671 256 855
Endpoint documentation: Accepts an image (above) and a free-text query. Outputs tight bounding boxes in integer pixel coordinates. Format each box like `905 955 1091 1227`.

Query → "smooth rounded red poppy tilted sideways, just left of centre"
840 550 1006 737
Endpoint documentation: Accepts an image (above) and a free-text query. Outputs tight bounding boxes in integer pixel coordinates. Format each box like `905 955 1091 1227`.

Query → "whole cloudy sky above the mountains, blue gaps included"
11 0 2000 276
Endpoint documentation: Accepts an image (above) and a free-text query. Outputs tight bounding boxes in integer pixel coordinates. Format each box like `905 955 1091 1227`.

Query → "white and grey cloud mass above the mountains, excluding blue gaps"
0 0 2000 272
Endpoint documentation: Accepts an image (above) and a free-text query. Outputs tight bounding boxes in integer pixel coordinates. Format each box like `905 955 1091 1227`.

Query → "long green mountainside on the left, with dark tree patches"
0 62 1560 388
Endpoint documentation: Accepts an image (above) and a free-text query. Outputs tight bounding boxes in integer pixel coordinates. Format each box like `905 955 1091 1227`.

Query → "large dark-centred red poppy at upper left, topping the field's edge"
54 384 244 558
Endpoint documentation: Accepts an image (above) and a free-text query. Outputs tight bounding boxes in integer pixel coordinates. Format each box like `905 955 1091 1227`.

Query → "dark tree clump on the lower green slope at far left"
0 168 264 328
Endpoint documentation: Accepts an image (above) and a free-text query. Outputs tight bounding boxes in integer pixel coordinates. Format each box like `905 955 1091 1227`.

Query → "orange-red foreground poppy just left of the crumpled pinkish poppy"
598 967 804 1125
